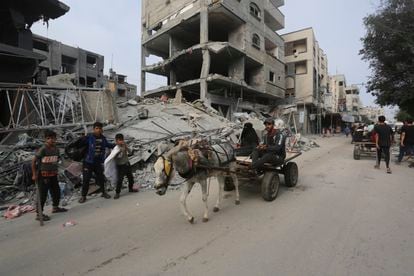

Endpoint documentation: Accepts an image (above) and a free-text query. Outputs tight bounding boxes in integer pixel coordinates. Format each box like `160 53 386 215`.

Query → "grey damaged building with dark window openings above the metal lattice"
33 35 104 88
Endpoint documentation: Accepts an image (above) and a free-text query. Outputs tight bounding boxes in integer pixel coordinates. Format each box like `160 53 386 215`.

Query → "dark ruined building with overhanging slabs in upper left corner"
0 0 69 83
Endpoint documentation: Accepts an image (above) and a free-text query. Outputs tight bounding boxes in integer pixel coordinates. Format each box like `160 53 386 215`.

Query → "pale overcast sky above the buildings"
32 0 392 113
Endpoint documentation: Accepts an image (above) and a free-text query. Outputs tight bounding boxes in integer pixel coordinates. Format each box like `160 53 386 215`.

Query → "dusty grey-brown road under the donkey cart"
0 137 414 276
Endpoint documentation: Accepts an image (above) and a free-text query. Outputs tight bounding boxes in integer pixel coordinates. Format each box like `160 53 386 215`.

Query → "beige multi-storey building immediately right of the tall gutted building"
282 28 329 133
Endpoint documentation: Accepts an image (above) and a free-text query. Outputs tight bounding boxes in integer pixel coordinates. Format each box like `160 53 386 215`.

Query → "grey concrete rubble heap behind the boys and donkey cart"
0 93 318 212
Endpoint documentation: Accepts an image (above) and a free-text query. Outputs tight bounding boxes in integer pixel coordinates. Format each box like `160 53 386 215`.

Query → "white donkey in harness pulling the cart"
154 141 240 223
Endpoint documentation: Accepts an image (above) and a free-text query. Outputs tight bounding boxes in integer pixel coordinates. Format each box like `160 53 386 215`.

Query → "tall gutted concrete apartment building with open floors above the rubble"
141 0 285 117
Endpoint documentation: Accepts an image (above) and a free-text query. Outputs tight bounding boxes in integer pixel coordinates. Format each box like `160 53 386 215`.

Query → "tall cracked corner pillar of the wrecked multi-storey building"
200 0 210 105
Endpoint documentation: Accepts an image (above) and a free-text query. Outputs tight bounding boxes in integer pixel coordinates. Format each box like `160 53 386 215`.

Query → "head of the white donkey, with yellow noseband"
154 155 174 195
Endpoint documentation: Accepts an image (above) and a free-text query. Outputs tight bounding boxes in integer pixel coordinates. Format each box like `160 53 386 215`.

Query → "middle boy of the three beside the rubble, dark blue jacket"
79 122 115 203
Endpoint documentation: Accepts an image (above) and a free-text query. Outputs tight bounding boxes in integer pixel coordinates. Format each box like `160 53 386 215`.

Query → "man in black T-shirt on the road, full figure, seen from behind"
374 116 393 173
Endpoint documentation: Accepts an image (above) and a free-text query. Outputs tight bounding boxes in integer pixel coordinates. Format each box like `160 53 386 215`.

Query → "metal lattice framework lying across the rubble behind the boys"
0 83 116 133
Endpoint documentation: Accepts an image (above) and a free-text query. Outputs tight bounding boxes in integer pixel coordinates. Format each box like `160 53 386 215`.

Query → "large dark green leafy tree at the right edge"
360 0 414 116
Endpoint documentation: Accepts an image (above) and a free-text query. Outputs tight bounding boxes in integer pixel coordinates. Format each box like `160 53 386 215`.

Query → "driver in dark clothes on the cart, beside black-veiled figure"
252 118 286 170
